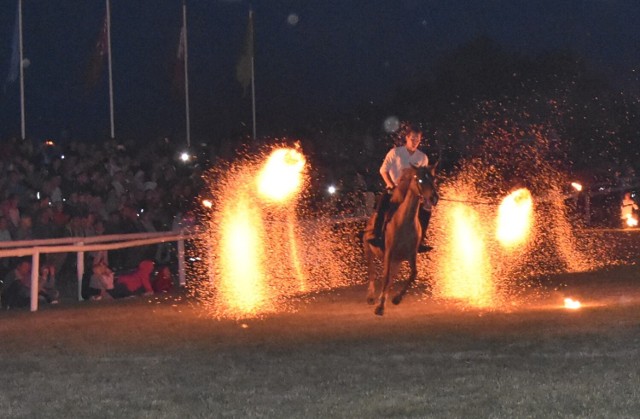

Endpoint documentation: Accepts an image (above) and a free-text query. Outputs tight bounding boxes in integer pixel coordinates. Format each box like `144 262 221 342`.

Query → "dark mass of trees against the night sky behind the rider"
318 37 640 184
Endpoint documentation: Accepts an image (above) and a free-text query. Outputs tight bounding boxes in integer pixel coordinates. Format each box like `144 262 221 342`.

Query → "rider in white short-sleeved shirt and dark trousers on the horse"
369 124 432 253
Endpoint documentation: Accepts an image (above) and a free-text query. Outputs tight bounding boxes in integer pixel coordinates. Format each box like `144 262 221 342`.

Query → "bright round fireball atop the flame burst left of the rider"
256 148 305 202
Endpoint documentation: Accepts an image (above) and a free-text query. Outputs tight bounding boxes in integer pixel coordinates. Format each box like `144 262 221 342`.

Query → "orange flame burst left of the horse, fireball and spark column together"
213 148 306 318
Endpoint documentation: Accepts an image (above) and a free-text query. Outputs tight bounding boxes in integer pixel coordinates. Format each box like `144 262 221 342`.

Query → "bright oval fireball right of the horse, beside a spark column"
496 189 533 248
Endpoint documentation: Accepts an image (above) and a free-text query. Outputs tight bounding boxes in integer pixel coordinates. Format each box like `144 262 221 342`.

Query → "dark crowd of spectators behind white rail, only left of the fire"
0 139 202 306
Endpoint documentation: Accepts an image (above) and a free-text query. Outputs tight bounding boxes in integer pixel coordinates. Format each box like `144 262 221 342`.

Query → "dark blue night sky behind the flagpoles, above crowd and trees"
0 0 640 146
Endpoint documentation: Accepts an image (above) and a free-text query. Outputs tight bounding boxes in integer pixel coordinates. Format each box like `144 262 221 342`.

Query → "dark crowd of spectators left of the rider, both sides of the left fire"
0 126 402 308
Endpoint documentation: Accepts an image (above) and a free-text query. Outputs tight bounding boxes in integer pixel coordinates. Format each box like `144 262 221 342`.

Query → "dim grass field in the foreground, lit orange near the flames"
0 266 640 418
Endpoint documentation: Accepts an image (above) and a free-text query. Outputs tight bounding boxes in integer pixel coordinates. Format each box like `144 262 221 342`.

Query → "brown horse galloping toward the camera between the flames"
363 163 438 316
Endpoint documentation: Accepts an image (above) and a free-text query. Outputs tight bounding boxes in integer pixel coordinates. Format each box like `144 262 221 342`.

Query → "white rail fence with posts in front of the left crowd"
0 230 198 311
